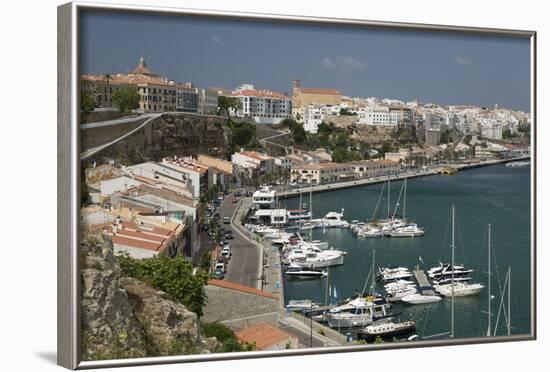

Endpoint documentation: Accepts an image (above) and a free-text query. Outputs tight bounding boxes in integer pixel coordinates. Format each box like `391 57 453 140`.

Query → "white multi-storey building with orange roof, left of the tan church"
231 84 292 124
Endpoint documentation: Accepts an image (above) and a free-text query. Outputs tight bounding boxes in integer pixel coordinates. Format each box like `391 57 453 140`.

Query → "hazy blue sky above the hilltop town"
80 11 530 111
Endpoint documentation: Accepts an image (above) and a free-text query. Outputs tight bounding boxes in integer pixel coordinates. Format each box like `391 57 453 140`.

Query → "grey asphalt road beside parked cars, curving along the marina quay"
218 194 261 288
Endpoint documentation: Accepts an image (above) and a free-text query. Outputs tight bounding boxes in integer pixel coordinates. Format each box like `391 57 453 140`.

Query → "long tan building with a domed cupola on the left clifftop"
80 57 217 114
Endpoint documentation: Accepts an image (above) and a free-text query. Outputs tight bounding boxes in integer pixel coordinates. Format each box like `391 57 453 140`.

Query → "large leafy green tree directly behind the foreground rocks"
117 252 209 317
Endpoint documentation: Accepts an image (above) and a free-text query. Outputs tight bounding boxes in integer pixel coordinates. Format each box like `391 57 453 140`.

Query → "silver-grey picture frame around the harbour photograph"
57 1 537 369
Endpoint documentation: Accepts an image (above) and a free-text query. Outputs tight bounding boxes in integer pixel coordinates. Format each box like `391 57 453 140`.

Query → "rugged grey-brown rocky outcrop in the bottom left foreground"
81 237 220 360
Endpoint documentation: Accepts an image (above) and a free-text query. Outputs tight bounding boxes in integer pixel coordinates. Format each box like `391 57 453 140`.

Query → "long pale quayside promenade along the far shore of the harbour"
277 155 531 199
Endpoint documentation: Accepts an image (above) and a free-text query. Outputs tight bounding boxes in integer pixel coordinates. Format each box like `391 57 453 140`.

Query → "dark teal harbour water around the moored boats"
280 165 531 338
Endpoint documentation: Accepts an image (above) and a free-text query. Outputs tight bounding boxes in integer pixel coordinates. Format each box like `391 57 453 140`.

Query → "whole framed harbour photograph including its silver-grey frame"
58 2 536 369
